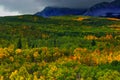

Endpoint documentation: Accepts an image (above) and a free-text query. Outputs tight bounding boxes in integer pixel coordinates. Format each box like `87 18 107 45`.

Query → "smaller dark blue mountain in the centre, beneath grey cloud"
35 7 86 17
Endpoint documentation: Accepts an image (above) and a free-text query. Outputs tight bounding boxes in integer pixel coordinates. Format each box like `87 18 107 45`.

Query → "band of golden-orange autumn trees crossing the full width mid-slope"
0 47 120 65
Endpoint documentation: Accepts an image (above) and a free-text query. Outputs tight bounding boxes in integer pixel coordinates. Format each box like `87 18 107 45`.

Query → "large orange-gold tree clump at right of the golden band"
70 48 120 65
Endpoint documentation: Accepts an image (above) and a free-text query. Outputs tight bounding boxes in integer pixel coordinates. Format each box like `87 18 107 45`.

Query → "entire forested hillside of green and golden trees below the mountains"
0 15 120 80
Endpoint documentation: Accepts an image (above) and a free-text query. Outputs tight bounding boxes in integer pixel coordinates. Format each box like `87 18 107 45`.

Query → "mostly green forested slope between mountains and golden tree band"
0 15 120 49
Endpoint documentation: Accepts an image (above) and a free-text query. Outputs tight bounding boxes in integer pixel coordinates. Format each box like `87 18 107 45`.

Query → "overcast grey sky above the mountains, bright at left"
0 0 113 16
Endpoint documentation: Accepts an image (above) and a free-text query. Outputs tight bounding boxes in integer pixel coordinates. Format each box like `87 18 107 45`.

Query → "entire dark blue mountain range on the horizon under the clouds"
35 0 120 18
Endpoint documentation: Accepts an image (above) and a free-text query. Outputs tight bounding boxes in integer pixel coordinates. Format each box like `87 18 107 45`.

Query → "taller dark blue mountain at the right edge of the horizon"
84 0 120 17
